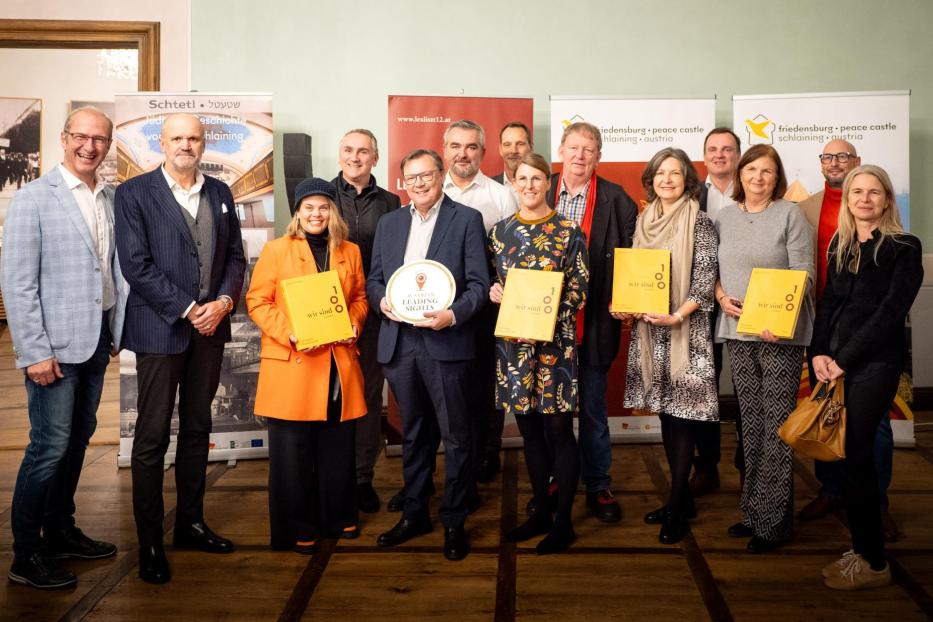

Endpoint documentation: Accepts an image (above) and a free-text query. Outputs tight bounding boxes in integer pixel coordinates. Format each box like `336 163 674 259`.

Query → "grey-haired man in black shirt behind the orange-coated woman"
333 129 401 512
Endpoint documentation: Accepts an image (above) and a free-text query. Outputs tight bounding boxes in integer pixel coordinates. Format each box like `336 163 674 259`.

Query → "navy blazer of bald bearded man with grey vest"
114 167 246 354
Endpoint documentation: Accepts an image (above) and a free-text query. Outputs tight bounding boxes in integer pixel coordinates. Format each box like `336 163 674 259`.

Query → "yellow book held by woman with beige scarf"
612 248 671 313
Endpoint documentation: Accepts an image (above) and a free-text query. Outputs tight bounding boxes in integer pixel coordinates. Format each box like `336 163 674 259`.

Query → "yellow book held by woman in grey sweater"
735 268 807 339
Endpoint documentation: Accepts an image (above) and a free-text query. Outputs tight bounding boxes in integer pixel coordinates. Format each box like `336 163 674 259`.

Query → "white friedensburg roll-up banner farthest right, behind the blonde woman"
732 91 914 447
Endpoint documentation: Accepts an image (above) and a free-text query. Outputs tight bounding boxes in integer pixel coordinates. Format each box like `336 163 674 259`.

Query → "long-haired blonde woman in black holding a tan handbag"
809 165 923 590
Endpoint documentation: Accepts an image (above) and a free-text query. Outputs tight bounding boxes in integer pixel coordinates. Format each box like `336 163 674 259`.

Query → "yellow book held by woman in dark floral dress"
496 268 564 341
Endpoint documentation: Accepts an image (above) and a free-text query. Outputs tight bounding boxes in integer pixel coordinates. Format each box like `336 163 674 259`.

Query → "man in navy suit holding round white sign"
366 149 489 560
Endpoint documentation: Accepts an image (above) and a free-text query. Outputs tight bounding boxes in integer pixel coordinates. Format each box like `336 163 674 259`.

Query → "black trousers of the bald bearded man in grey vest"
131 328 224 546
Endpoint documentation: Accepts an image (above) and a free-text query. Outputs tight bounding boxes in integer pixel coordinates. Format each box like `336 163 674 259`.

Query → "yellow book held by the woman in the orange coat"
280 270 353 350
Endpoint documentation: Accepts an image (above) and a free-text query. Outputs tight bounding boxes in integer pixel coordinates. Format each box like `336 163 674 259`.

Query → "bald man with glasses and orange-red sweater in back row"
800 140 898 542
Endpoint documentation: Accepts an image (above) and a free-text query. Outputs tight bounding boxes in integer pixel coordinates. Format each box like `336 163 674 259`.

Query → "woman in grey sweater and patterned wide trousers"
716 145 813 553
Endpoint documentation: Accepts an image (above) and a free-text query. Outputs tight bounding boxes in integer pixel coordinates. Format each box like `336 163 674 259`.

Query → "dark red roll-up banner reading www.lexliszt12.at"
385 95 543 454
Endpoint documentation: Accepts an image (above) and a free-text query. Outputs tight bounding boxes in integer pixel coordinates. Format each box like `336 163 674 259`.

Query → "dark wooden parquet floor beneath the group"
0 325 933 622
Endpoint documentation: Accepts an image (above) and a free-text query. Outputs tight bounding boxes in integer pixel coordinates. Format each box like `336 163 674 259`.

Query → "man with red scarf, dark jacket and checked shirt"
548 121 638 523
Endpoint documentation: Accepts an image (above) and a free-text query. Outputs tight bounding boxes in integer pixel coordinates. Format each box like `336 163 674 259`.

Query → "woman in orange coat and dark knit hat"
246 178 368 554
